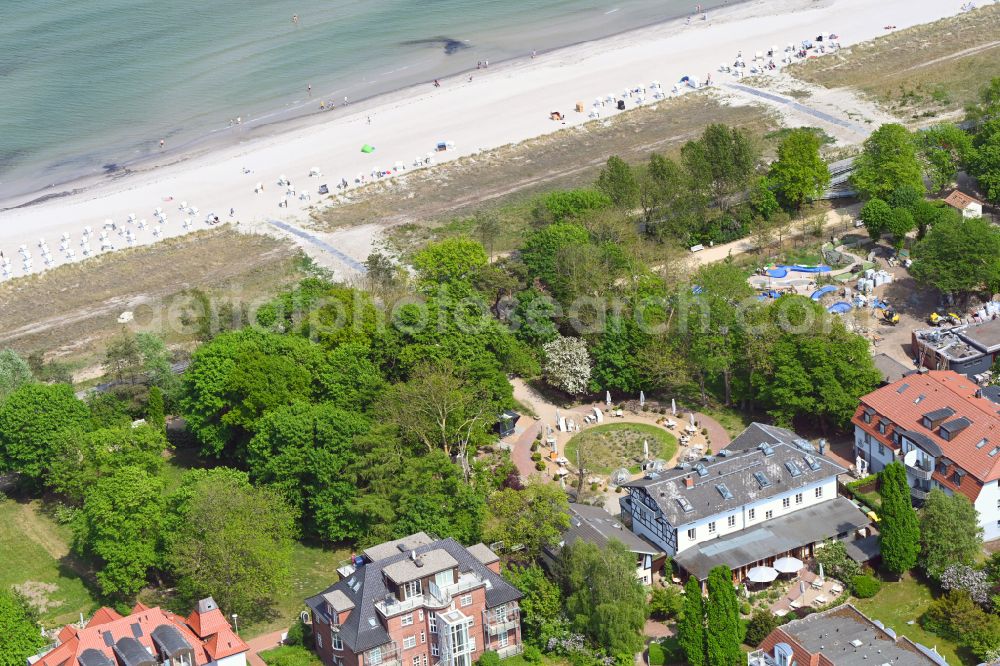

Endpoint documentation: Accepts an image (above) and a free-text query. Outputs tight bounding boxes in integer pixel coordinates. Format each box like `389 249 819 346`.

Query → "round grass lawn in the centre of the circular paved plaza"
566 423 677 474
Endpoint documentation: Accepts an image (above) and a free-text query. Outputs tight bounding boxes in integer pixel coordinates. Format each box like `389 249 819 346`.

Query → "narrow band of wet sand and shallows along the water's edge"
0 0 754 208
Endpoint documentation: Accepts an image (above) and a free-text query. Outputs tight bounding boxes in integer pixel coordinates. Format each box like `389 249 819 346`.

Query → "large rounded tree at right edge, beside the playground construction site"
910 216 1000 294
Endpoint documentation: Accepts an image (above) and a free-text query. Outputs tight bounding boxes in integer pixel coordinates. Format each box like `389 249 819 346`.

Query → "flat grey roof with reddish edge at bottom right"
781 604 945 666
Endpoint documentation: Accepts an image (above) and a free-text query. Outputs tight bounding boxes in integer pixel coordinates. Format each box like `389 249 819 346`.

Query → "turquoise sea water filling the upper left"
0 0 723 198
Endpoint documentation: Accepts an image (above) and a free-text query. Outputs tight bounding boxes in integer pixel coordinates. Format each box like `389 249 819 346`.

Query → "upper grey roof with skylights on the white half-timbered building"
624 443 847 527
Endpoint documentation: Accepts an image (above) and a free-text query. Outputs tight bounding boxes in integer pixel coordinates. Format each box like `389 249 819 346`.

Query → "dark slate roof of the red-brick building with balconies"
306 532 521 654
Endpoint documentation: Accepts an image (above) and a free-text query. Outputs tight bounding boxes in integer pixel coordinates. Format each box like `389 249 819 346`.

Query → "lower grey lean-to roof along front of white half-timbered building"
674 497 871 580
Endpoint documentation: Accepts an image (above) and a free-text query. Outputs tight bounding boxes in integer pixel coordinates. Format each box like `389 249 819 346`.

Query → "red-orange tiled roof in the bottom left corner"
37 604 249 666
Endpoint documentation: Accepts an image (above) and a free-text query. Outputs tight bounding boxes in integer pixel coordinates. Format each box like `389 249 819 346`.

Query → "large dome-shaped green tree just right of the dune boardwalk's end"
851 123 924 200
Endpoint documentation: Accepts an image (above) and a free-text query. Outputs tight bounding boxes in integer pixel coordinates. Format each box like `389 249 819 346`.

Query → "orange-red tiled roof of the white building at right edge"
852 370 1000 482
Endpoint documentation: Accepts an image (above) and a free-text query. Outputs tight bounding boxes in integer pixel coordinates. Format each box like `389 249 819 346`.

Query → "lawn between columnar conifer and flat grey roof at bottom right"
852 575 977 664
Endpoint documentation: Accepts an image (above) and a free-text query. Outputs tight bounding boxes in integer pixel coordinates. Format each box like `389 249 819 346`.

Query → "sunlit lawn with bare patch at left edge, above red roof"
0 495 99 628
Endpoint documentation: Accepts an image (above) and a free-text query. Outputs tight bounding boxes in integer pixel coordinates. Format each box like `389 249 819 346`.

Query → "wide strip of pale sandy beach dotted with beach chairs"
0 0 961 279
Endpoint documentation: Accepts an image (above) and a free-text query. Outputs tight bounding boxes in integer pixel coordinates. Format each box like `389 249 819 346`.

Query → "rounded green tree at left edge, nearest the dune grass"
0 384 91 483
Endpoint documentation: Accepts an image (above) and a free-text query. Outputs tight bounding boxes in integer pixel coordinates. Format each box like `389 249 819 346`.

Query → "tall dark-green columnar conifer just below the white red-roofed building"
879 461 920 575
